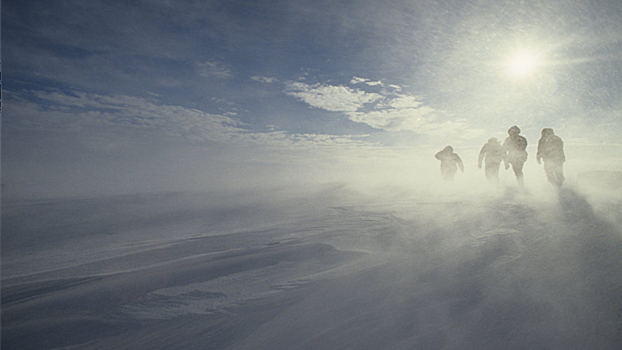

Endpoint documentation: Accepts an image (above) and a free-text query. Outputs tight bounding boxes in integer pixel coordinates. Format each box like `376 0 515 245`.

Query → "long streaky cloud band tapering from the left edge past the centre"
3 90 380 150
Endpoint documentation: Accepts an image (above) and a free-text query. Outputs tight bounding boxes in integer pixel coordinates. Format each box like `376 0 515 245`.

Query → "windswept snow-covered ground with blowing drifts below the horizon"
2 185 622 350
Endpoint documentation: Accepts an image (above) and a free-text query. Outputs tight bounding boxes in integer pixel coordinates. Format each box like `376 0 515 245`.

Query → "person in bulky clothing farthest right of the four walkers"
536 128 566 187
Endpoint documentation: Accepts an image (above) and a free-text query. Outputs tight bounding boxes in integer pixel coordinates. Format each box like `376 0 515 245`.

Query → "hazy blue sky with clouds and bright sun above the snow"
2 0 622 197
